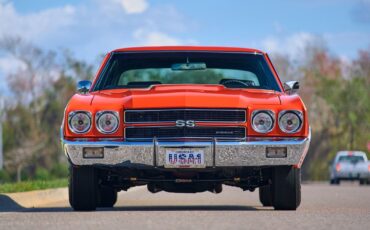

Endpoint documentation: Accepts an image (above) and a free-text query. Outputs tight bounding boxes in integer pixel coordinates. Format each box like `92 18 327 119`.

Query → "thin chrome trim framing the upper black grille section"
124 108 247 124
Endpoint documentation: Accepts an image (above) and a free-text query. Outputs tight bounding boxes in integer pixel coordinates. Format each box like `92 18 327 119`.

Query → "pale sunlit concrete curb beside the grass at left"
0 188 68 211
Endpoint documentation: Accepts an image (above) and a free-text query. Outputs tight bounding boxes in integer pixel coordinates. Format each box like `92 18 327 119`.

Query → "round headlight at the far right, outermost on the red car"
279 111 303 133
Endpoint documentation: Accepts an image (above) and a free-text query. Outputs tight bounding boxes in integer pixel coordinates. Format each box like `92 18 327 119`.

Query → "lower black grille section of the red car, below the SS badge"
125 126 246 139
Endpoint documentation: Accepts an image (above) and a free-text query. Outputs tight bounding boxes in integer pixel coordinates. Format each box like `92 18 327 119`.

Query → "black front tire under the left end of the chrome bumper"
68 166 97 211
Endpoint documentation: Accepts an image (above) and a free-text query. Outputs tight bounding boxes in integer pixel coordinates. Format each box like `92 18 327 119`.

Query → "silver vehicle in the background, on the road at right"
330 151 370 185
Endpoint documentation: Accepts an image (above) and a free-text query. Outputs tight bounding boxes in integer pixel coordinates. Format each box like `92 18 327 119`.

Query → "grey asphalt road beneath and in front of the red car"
0 183 370 230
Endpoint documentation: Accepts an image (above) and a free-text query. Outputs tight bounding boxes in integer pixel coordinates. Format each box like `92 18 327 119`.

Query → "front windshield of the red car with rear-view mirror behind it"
93 51 280 91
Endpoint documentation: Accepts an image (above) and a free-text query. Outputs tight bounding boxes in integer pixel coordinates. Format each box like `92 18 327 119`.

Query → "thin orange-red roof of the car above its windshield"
111 46 264 54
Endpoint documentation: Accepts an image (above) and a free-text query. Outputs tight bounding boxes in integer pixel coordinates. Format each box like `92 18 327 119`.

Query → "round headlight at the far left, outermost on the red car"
68 111 91 134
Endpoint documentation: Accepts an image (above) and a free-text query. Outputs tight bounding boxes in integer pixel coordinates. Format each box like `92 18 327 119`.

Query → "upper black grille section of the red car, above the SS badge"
125 109 246 123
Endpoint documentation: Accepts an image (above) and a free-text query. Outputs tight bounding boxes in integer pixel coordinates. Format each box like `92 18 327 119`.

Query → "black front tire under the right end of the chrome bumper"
271 166 301 210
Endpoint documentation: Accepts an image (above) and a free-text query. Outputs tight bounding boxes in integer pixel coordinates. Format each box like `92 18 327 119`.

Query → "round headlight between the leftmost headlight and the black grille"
96 111 119 134
